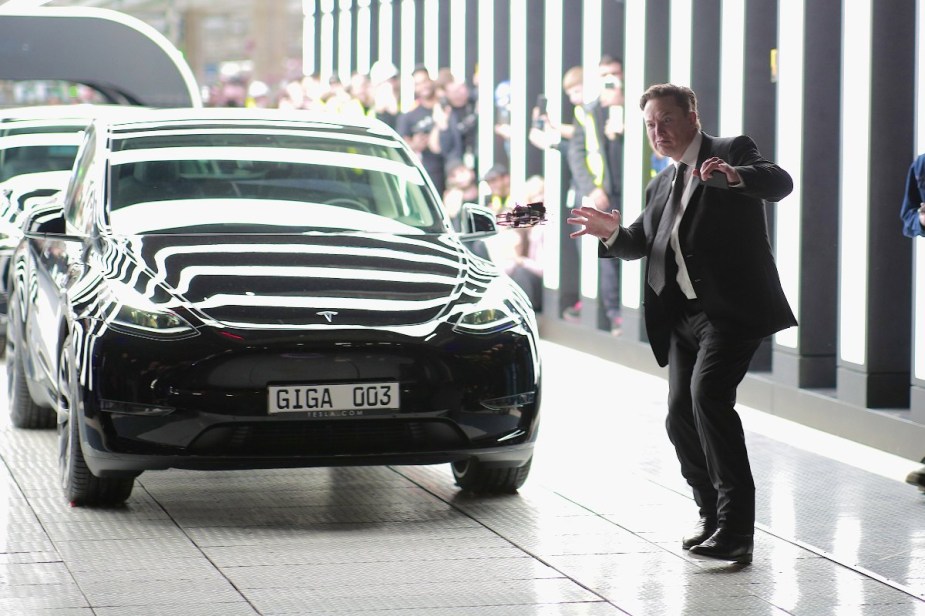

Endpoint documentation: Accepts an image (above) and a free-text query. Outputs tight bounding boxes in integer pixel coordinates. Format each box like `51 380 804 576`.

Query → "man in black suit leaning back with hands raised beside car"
568 84 796 563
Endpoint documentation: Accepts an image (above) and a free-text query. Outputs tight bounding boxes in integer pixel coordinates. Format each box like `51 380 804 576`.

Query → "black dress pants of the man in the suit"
665 300 761 534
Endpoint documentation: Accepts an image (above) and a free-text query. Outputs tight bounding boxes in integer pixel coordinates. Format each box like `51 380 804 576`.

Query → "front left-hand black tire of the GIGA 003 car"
58 338 135 507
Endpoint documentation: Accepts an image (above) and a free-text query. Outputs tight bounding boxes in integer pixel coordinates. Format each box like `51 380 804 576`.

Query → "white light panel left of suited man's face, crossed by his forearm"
620 0 648 309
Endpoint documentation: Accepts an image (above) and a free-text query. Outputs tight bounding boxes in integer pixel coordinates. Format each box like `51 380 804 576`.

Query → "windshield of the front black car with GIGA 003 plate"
108 127 445 235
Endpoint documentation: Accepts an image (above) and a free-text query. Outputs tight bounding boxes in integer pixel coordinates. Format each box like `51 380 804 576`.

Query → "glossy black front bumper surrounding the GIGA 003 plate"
81 332 540 476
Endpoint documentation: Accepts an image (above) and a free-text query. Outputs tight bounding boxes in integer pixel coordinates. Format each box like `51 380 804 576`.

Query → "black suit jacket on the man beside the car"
599 134 797 366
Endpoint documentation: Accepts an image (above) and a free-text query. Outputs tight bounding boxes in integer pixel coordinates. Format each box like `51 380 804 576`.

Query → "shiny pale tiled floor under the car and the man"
0 343 925 616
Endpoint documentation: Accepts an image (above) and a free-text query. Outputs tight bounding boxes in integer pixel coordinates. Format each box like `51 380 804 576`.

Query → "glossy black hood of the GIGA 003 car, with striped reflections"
106 233 495 329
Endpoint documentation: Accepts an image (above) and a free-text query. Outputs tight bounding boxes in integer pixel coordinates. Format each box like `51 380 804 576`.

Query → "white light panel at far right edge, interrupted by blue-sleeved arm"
912 0 925 380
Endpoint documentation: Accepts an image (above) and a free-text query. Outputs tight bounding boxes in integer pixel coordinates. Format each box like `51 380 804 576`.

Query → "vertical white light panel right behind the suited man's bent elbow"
769 0 806 349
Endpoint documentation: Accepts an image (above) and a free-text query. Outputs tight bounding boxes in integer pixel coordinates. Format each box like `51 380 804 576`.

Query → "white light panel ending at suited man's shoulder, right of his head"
719 0 745 136
